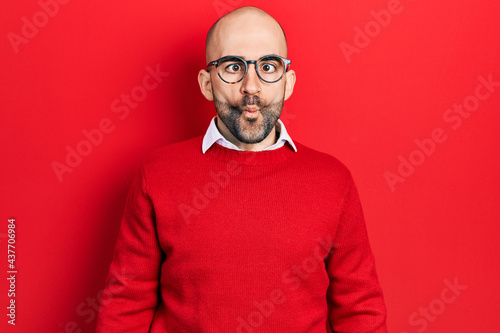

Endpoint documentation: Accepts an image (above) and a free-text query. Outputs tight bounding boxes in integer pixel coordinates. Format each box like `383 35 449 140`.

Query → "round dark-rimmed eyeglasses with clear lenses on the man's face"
207 55 292 84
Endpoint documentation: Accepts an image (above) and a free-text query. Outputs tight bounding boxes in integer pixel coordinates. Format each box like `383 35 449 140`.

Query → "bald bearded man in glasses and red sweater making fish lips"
97 7 387 333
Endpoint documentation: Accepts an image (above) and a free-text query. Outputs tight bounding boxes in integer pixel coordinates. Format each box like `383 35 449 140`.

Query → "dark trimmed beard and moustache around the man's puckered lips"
214 95 284 143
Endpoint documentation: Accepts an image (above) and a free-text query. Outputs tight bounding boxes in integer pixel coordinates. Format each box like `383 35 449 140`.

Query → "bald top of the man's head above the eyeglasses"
205 6 287 63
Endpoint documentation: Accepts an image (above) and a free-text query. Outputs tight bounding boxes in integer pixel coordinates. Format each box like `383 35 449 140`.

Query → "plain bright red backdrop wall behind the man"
0 0 500 333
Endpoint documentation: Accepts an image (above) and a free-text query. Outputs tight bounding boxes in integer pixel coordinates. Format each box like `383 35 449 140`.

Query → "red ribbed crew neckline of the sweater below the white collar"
205 142 296 165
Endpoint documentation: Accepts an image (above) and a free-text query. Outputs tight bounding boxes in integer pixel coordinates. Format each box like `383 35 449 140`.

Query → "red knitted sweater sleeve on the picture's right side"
326 175 387 333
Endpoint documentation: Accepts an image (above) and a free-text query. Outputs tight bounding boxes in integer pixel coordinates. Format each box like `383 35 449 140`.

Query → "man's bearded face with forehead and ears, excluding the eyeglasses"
200 8 295 143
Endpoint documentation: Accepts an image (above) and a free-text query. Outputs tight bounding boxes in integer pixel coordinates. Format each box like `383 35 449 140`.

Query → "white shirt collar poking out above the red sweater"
201 116 297 154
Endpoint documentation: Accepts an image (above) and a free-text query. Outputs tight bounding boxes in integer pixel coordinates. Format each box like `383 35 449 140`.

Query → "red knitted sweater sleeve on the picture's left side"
96 166 162 333
